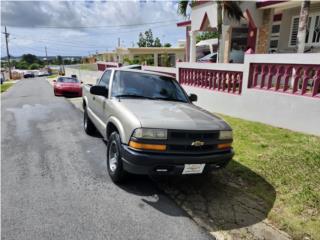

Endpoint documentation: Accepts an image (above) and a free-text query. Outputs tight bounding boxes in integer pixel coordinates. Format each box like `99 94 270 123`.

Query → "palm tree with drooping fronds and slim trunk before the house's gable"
178 0 244 62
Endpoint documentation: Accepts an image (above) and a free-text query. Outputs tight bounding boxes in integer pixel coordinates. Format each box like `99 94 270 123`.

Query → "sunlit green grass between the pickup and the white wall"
223 116 320 239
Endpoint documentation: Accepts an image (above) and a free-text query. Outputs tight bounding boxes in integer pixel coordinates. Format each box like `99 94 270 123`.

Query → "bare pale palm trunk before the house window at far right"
298 0 310 53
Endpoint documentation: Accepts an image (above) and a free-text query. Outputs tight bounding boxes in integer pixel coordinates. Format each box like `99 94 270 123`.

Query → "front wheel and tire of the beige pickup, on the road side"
107 132 127 183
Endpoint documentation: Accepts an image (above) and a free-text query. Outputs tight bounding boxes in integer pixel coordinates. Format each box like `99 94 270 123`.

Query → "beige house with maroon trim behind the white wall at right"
177 1 320 63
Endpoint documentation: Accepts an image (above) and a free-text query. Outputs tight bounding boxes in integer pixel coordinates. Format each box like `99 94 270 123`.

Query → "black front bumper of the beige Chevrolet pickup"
121 144 234 175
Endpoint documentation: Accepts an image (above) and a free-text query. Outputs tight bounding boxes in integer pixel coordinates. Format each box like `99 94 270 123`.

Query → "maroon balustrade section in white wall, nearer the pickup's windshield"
179 65 243 94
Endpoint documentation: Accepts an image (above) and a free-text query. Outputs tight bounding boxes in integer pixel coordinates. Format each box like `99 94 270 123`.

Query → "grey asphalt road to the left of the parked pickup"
1 78 211 240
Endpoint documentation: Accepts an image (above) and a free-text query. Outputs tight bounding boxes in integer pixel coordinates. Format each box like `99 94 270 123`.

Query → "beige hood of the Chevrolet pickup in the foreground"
119 99 231 130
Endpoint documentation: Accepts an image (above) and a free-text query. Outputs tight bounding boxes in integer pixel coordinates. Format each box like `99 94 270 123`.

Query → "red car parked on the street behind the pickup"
53 77 82 97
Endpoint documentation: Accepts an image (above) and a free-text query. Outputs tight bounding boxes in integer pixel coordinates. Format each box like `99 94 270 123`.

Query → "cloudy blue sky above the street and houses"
1 0 185 57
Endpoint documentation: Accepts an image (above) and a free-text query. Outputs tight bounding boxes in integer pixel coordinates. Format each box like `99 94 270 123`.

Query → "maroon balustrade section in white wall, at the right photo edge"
248 63 320 98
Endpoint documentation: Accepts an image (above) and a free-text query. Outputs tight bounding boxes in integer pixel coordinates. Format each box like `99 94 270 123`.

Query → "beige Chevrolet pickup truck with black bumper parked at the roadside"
83 68 234 183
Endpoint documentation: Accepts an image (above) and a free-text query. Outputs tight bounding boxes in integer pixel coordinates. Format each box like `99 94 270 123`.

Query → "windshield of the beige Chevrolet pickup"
111 71 188 102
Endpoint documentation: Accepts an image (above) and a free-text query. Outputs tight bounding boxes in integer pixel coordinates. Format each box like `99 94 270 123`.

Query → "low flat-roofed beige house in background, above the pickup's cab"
95 45 185 67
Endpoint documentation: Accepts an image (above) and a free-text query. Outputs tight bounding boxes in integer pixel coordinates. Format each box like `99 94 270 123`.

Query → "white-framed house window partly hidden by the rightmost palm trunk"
289 13 320 47
